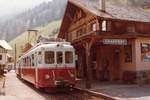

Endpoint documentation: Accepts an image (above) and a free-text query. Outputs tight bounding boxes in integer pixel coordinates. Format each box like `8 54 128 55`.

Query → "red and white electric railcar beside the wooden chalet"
16 42 76 88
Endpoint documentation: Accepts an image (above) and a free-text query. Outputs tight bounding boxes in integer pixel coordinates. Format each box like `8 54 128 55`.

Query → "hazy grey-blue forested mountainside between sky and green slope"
0 0 67 41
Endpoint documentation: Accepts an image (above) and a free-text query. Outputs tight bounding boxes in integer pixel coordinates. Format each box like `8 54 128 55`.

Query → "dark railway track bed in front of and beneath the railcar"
19 76 105 100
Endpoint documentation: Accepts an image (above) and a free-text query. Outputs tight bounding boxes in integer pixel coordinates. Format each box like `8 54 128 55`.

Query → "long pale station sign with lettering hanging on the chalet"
102 39 128 45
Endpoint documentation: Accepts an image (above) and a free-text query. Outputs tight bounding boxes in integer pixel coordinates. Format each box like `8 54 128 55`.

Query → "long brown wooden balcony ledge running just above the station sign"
70 31 150 42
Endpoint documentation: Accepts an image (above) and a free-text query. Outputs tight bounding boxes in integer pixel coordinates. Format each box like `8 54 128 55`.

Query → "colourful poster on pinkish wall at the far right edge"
141 43 150 62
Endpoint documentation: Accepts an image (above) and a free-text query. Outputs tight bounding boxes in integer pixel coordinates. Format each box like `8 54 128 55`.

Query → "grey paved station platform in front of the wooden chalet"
76 80 150 100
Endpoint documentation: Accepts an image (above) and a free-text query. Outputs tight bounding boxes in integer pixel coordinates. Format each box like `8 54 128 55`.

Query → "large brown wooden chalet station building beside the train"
58 0 150 87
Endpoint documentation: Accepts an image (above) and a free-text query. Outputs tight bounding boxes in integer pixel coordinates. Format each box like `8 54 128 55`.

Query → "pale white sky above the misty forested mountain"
0 0 52 17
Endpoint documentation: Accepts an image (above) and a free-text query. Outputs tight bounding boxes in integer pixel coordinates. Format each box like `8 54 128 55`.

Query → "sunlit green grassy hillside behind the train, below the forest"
10 20 61 57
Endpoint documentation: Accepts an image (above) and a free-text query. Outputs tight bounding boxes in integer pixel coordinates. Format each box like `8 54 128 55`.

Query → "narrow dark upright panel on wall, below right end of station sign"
125 45 132 63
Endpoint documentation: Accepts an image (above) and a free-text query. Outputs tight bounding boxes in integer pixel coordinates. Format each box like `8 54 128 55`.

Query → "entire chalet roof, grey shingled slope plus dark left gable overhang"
58 0 150 38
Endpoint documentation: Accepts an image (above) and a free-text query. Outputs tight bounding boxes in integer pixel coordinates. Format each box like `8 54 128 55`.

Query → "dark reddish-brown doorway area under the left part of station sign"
99 45 121 81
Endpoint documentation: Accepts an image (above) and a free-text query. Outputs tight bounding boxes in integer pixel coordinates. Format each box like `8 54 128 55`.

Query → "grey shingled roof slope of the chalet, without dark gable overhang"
69 0 150 22
